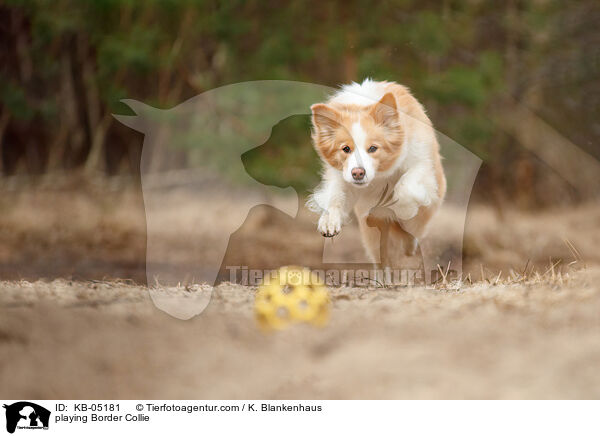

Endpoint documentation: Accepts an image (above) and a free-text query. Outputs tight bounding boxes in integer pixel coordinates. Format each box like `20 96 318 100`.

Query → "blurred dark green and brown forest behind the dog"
0 0 600 208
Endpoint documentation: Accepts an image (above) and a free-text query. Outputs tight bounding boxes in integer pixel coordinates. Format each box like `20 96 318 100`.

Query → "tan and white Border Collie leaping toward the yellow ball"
307 79 446 268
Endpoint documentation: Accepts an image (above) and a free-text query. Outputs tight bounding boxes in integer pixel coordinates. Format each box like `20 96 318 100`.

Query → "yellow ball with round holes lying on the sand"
254 266 330 330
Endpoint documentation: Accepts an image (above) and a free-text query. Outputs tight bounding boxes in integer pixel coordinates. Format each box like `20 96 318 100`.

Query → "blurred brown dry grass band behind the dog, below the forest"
0 188 600 283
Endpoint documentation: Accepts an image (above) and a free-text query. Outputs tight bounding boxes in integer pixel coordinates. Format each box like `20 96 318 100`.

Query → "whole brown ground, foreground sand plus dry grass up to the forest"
0 185 600 399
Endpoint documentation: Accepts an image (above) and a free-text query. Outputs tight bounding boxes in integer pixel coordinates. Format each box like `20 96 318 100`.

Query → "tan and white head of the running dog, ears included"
311 93 404 187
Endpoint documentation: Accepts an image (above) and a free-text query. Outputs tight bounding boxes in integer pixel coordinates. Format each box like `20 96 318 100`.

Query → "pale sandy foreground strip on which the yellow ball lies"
0 269 600 399
